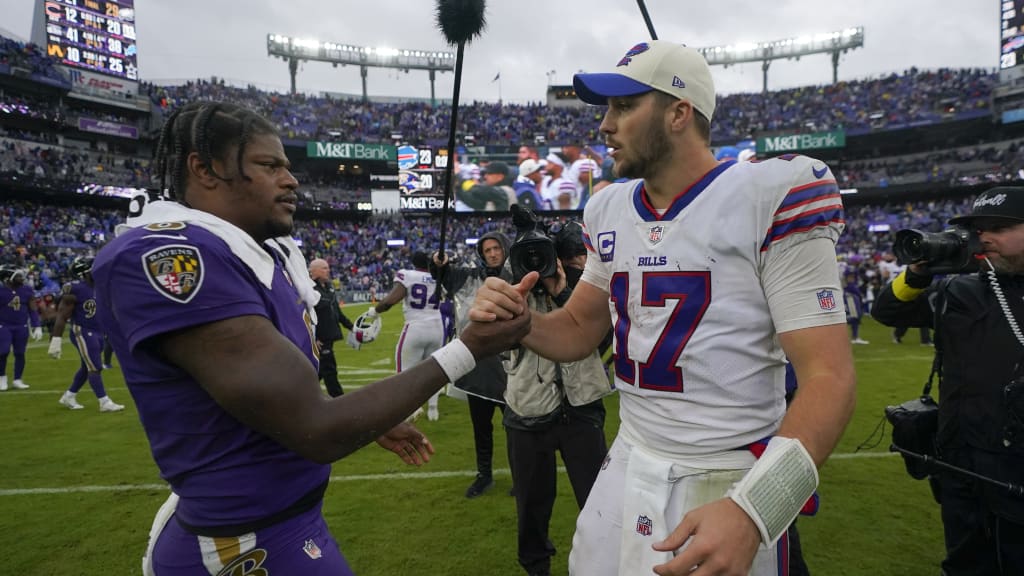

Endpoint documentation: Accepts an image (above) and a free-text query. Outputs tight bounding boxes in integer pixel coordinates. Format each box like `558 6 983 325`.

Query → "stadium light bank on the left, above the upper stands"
266 34 455 105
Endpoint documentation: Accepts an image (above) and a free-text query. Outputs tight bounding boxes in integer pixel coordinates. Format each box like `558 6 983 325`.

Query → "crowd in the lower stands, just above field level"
0 192 970 309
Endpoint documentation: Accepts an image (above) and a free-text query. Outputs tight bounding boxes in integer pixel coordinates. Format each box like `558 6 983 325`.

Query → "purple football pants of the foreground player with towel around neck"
153 504 354 576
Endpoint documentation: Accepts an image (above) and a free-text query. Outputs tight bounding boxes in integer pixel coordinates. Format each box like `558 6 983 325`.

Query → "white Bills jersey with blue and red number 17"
583 155 846 457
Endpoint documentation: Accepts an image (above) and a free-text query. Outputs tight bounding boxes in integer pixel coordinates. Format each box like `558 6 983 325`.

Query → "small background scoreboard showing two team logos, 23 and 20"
398 145 454 211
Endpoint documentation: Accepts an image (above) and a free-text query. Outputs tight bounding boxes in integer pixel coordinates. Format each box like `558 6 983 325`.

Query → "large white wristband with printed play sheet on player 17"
728 436 818 546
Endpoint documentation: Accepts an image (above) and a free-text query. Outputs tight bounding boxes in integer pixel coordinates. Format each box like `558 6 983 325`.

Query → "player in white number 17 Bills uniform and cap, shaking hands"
470 40 855 576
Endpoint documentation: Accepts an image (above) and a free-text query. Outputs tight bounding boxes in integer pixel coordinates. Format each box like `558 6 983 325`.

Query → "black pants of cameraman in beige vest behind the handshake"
505 409 608 574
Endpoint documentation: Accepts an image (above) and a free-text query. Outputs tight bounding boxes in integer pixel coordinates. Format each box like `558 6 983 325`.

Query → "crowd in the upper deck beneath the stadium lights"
146 69 995 146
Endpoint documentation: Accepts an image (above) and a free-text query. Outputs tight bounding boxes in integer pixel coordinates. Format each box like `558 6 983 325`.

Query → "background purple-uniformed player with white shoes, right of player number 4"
48 256 125 412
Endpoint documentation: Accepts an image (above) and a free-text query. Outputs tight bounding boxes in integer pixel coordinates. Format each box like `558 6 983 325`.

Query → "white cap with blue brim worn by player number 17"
572 40 715 120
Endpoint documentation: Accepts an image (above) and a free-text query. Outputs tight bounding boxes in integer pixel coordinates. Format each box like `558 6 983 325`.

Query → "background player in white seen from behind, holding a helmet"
370 252 444 420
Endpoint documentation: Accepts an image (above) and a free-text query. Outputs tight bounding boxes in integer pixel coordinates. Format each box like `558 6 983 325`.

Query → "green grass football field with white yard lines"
0 305 943 576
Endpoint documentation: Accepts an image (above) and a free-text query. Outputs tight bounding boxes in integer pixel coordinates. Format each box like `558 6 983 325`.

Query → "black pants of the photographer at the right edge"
940 448 1024 576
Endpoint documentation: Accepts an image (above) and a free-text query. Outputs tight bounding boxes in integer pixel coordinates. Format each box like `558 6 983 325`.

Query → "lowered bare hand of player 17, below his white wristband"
653 498 761 576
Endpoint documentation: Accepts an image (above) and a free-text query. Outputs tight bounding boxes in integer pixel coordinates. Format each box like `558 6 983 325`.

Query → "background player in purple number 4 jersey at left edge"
0 266 43 392
